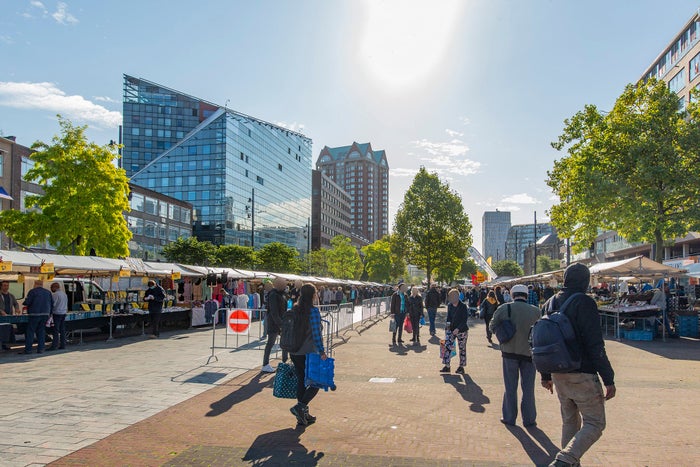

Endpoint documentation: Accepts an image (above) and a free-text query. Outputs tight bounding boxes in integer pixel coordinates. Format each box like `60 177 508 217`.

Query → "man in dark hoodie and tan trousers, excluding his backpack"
542 263 615 467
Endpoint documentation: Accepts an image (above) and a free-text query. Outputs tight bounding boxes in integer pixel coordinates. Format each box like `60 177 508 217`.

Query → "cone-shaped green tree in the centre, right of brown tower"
394 167 472 281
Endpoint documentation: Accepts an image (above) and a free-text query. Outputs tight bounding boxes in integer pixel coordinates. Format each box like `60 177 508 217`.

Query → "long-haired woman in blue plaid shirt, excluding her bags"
289 284 328 426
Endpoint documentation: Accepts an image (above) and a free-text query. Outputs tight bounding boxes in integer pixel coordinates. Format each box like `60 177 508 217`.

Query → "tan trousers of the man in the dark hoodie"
552 373 605 464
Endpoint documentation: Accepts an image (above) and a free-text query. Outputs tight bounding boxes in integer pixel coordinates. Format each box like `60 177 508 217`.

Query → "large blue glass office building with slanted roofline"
122 75 311 251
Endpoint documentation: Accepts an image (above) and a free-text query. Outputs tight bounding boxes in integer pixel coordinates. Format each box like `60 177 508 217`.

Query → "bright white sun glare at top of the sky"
359 0 466 90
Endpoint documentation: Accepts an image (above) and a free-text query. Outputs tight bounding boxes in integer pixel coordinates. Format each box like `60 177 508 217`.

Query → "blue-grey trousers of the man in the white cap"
502 357 537 426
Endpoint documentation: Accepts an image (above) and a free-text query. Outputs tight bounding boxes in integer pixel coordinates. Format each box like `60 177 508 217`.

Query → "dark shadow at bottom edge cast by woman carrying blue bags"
242 426 324 467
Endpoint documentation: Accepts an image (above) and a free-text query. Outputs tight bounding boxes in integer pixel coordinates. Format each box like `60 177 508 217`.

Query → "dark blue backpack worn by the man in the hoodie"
530 292 583 373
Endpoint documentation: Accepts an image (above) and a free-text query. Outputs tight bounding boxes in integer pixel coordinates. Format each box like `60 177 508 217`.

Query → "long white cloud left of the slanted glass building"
0 81 122 128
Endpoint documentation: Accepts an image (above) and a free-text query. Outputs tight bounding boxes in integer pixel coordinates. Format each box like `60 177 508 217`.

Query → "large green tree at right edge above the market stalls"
547 79 700 261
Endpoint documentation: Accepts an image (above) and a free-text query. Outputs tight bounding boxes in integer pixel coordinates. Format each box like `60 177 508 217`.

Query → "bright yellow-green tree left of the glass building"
0 115 131 257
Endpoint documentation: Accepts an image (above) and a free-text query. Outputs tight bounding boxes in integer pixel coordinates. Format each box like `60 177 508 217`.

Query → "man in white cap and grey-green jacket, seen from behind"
489 285 540 427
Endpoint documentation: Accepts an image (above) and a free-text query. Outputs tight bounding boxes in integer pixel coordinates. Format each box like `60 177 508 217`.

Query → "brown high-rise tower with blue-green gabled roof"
316 142 389 243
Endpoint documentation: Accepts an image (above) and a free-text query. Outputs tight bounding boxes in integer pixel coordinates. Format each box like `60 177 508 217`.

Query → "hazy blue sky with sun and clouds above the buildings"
0 0 700 254
